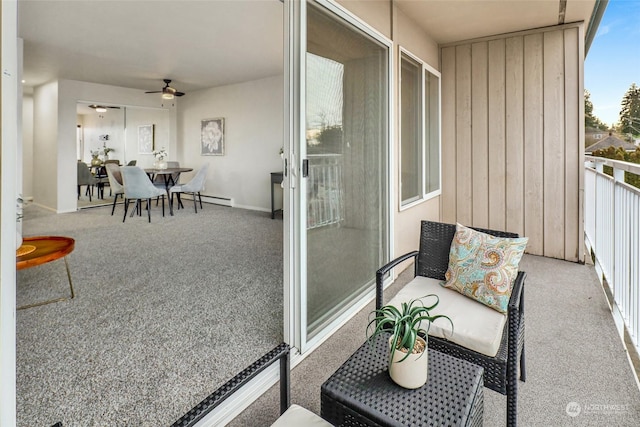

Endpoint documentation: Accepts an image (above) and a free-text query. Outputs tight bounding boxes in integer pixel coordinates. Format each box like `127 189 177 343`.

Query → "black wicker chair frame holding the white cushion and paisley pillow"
376 221 526 426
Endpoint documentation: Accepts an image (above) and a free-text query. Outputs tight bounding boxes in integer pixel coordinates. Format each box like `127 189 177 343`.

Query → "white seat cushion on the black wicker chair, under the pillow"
389 276 507 357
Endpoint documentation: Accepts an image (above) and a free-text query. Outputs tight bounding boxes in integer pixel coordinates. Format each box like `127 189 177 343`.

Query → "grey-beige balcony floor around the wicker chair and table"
230 255 640 427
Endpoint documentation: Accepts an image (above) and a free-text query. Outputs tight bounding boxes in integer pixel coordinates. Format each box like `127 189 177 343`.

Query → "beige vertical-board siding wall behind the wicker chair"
441 25 583 261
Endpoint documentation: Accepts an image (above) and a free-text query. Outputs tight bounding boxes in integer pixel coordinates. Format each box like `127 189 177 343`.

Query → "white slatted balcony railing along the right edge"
584 156 640 356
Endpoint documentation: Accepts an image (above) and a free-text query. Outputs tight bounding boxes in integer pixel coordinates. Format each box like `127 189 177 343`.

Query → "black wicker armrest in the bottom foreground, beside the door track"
172 343 291 427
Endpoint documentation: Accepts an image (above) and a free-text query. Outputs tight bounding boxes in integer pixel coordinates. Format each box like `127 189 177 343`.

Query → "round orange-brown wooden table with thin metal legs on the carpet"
16 236 75 310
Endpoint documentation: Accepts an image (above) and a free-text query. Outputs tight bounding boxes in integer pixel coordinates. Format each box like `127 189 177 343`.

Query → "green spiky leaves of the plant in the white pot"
367 294 453 363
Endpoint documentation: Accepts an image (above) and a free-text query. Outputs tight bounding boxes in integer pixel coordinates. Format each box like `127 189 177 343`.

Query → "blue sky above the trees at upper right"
584 0 640 125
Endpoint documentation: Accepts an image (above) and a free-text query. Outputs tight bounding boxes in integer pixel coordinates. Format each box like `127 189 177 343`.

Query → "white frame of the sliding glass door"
283 0 393 357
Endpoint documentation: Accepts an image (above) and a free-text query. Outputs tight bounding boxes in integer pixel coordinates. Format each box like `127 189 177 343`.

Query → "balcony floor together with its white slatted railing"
230 189 640 427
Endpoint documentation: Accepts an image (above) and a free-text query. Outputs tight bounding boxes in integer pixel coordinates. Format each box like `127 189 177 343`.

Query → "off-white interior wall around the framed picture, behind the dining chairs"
178 75 284 211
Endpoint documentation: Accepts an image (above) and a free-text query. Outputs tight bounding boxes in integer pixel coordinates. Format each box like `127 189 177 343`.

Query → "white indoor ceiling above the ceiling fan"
18 0 283 92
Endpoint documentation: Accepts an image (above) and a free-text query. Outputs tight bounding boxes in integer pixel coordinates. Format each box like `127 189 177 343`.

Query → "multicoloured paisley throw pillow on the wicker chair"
442 224 529 313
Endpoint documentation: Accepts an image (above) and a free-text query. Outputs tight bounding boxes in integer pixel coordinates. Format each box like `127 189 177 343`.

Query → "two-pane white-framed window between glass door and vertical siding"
400 51 440 208
